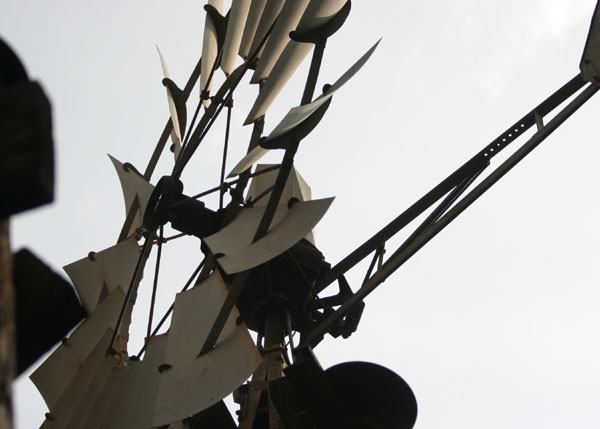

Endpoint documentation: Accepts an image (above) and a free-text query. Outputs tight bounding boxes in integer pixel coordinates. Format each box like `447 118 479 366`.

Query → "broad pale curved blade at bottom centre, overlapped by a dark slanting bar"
154 271 261 426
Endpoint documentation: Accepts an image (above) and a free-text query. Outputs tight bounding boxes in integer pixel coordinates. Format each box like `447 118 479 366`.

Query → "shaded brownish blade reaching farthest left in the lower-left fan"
30 288 125 409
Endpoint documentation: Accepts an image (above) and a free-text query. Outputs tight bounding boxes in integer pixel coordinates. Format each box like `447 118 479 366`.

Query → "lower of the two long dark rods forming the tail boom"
299 79 600 347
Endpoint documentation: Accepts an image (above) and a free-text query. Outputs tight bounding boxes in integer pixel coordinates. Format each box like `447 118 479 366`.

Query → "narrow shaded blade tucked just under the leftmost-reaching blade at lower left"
41 328 115 429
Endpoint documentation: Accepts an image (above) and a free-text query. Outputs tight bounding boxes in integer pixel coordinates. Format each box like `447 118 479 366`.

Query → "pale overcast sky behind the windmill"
0 0 600 429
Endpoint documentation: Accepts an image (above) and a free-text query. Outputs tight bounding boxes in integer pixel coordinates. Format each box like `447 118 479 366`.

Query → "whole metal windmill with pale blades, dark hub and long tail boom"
1 0 600 429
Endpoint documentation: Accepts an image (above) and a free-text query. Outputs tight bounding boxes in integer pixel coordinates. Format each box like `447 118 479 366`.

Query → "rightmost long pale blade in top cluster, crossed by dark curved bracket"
244 0 346 125
